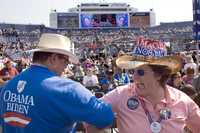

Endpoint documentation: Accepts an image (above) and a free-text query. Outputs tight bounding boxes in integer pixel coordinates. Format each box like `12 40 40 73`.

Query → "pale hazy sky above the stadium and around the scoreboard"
0 0 193 26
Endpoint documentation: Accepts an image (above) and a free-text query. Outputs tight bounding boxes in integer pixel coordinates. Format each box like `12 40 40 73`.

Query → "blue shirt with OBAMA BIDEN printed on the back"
0 65 114 133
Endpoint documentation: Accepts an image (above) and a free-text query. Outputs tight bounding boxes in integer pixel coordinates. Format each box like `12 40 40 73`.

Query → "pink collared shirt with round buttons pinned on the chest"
102 84 200 133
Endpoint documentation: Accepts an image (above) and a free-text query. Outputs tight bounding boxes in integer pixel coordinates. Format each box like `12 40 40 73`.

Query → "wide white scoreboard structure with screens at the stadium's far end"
50 3 155 29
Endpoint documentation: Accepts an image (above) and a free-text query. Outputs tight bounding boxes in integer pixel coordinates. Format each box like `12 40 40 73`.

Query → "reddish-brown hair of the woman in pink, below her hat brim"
149 65 171 88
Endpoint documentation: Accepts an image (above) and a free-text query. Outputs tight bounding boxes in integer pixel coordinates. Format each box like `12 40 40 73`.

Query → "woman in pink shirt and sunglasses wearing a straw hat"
87 55 200 133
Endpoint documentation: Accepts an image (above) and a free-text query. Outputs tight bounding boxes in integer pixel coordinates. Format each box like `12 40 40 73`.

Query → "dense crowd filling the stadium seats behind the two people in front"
0 22 200 132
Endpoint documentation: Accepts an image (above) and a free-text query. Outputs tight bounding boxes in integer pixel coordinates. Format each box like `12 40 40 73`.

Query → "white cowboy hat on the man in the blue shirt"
31 33 79 64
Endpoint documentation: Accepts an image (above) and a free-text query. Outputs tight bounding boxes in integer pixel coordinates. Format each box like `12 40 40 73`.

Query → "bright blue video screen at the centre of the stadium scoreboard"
80 13 128 28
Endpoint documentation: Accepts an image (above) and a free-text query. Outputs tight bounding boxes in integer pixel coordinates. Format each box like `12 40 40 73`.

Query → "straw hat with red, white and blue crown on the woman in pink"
116 37 181 73
